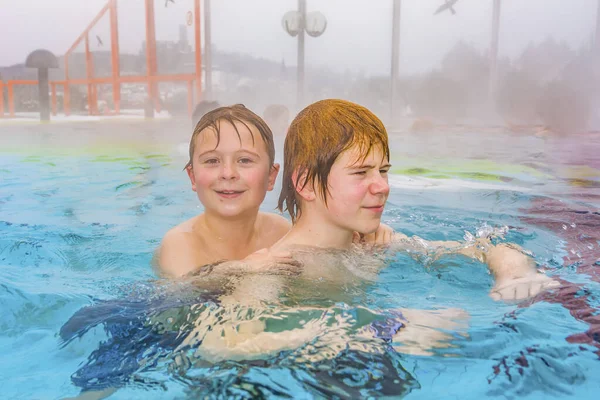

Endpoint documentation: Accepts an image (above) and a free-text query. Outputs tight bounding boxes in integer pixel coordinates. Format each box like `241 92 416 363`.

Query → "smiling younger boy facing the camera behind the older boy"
158 104 290 277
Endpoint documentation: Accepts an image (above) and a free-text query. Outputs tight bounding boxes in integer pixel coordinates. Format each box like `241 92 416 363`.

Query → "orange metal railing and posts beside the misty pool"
0 0 202 118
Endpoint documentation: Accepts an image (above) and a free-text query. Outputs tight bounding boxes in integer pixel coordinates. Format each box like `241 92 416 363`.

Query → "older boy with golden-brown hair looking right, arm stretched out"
272 100 551 299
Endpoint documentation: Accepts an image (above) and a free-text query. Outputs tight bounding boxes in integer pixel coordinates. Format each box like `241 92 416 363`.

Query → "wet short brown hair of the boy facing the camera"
184 104 275 169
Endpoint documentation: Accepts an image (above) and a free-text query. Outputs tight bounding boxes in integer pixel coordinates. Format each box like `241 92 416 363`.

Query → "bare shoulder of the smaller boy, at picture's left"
155 219 205 278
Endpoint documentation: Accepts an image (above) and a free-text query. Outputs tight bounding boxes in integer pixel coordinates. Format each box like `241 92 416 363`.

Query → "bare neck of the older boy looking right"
280 210 354 249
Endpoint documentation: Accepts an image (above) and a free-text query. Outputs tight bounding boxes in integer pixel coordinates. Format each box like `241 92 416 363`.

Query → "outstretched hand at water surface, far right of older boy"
490 273 560 300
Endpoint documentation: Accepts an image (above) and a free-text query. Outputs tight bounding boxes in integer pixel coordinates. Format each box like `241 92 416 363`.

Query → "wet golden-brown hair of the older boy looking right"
277 99 390 222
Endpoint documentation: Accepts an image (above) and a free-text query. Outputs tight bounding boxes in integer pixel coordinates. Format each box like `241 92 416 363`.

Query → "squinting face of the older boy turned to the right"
314 146 391 234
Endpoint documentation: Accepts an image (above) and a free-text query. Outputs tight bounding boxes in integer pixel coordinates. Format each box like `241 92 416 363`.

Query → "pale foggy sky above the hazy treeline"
0 0 598 74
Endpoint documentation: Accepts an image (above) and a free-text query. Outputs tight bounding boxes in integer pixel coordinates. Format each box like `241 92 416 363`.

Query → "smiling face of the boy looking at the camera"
187 120 279 218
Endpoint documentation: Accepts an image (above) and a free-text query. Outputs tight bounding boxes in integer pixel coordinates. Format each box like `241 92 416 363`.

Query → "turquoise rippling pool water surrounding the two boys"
0 124 600 399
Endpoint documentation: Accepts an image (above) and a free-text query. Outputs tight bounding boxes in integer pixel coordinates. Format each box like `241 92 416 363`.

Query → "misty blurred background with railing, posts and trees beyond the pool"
0 0 600 135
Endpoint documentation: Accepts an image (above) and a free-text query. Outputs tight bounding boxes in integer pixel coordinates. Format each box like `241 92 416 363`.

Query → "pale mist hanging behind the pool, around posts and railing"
0 0 598 132
